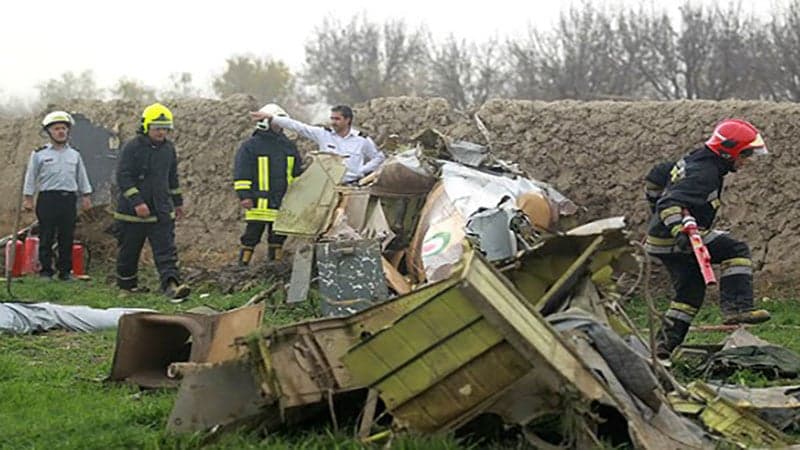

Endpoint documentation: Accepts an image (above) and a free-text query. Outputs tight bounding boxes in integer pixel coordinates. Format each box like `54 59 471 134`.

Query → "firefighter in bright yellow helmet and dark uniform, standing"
114 103 190 301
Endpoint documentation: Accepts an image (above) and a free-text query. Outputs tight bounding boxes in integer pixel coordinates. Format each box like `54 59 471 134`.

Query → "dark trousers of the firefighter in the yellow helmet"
115 219 180 290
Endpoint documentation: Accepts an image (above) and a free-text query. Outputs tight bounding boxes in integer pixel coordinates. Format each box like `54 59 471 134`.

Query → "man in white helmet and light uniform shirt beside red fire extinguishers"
22 111 92 280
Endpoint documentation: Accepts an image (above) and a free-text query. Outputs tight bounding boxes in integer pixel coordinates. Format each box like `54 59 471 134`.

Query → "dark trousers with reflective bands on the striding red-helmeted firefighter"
656 234 753 314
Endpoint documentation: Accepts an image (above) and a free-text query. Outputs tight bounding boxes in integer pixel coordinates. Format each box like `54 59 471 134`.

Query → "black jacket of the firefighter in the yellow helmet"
114 134 183 222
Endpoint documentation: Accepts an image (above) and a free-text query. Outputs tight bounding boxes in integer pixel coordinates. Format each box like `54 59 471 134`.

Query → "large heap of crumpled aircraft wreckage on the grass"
106 125 792 449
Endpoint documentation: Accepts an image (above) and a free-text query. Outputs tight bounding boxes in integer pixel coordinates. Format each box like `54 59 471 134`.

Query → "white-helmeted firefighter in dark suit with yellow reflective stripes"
233 103 301 266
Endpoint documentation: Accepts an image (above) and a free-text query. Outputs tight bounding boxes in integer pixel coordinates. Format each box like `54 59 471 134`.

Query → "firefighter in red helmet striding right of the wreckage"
645 119 770 359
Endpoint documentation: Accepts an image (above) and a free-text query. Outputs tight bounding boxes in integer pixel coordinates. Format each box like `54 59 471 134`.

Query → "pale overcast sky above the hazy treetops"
0 0 782 100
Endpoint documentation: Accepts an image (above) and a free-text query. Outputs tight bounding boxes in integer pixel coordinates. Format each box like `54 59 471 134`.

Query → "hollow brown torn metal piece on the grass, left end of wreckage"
109 304 264 388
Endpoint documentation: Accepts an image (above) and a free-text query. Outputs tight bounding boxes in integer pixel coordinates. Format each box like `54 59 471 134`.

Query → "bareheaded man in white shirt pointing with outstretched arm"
250 105 386 183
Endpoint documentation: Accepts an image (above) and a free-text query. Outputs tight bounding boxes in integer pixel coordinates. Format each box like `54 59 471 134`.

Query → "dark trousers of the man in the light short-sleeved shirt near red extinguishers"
36 191 78 277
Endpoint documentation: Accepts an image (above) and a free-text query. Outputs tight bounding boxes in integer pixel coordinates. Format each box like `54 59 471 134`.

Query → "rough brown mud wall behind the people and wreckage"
0 96 800 289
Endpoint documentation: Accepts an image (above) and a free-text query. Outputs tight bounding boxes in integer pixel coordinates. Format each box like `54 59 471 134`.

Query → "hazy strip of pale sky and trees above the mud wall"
0 0 788 115
